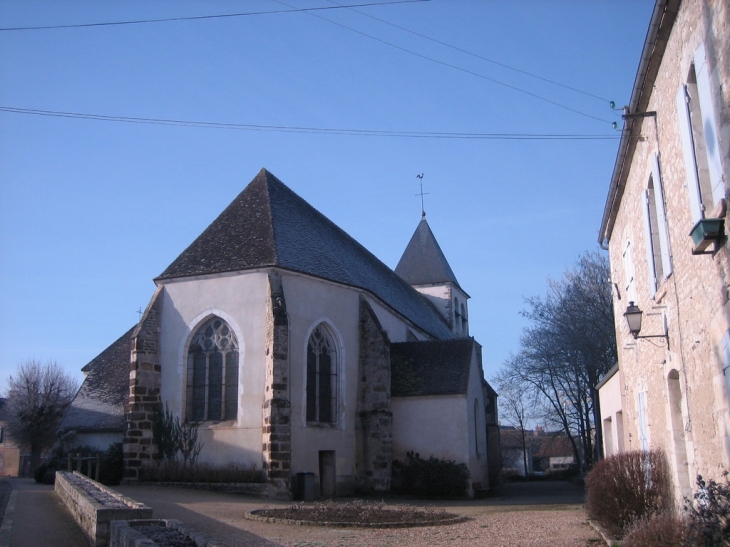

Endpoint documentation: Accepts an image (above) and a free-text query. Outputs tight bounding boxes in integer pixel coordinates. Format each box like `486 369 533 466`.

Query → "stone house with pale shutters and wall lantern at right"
599 0 730 498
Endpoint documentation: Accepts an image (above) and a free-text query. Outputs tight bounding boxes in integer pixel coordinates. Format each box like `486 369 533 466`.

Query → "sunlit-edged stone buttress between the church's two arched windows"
262 273 291 490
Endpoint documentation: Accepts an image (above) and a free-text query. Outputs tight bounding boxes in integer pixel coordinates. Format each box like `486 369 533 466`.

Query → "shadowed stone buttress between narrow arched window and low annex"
355 296 393 492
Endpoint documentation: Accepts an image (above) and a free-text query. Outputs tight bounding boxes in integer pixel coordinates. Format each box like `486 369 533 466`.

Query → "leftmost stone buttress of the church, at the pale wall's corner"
123 287 163 480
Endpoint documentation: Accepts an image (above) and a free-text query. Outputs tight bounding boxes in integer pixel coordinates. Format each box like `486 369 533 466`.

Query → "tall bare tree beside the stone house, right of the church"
494 253 617 469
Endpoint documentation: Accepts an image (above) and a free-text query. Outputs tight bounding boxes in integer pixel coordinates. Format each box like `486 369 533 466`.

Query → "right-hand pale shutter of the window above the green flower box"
694 44 725 203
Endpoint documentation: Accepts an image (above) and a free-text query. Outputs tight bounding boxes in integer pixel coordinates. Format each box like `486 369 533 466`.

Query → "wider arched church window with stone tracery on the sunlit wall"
187 317 238 422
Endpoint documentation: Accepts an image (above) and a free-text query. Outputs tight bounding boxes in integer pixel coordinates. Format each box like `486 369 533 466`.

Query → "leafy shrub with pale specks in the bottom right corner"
684 471 730 547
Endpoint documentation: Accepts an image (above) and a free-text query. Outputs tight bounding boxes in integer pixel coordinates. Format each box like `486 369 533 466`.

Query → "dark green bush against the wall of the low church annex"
391 452 471 498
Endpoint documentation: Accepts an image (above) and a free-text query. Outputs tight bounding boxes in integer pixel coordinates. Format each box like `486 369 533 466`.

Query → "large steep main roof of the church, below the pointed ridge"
157 169 453 338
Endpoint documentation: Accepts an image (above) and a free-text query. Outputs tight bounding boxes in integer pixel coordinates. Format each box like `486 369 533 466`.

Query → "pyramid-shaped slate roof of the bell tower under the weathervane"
395 218 461 288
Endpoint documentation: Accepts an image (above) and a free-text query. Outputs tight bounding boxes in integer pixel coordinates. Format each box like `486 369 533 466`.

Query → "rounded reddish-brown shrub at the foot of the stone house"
585 451 673 538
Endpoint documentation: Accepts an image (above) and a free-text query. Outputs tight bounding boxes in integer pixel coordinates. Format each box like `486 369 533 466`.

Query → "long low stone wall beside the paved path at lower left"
55 471 152 547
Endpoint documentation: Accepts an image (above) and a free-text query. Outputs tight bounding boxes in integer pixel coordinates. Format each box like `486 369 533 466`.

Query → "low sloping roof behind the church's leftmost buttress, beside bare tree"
59 328 134 432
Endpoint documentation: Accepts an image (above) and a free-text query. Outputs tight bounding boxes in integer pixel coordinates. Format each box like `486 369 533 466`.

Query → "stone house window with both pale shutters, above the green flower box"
676 44 725 223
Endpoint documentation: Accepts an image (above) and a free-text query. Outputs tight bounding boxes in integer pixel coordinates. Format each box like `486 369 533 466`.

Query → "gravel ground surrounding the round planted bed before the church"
116 482 602 547
